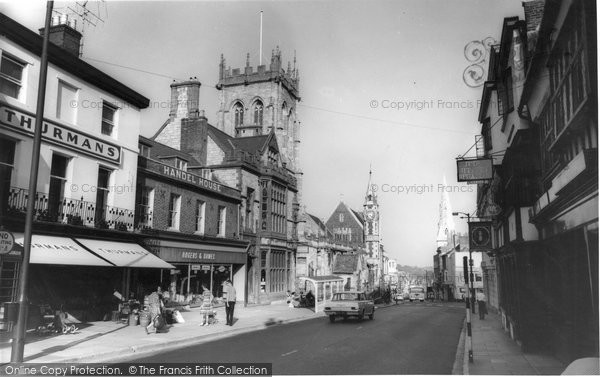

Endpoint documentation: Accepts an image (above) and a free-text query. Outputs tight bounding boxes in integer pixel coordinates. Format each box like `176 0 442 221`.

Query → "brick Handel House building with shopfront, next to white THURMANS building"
136 135 247 301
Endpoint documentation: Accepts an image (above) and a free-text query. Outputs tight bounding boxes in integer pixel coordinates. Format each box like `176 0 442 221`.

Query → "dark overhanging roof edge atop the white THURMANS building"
0 13 150 109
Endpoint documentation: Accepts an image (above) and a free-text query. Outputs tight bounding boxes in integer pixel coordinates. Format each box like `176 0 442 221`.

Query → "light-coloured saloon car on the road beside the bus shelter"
323 291 375 322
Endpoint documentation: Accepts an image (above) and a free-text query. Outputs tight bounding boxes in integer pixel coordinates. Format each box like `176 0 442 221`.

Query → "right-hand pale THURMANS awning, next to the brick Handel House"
76 238 175 269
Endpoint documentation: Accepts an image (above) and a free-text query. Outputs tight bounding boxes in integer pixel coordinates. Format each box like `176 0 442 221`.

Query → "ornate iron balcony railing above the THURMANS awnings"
0 187 134 231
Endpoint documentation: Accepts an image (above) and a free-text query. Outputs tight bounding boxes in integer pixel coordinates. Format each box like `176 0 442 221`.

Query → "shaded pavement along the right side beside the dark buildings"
463 311 567 375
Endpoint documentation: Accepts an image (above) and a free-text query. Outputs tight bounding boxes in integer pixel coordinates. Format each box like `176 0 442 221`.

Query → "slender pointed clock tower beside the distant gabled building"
363 171 382 266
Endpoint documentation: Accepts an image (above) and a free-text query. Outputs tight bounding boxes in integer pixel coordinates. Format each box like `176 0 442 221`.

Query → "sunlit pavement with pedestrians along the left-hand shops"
0 303 323 364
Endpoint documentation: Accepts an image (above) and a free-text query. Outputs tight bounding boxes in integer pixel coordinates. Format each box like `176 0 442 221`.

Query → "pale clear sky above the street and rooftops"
0 0 523 267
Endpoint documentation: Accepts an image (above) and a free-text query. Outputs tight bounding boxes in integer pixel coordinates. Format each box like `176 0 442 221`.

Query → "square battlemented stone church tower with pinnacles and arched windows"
217 47 300 173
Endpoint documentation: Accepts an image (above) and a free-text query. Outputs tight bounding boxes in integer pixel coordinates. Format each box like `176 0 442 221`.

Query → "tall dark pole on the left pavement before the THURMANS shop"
10 1 54 363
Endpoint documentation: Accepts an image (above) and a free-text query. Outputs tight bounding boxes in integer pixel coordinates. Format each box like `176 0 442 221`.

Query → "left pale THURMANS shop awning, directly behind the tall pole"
14 233 112 266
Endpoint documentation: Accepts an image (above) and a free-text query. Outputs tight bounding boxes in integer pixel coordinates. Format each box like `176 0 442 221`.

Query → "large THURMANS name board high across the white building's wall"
0 105 121 164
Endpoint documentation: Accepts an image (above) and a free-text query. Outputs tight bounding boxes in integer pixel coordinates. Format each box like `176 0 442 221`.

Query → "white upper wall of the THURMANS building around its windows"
0 37 141 211
